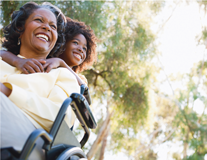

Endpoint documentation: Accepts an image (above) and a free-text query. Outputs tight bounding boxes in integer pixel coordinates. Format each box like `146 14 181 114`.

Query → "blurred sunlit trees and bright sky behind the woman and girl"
0 0 207 160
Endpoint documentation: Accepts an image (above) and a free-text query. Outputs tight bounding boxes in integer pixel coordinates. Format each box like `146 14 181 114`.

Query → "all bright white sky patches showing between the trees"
105 0 207 160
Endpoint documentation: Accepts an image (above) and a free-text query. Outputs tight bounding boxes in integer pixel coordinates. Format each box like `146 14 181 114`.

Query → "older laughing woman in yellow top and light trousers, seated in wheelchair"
0 2 80 159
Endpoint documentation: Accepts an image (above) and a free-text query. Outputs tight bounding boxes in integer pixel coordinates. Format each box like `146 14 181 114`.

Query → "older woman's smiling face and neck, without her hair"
20 8 58 58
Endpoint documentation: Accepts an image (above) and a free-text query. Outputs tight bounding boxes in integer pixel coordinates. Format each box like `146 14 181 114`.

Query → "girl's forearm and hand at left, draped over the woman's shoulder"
0 50 46 74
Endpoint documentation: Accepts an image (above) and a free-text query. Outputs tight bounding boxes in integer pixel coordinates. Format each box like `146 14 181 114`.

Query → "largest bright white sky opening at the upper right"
158 1 207 73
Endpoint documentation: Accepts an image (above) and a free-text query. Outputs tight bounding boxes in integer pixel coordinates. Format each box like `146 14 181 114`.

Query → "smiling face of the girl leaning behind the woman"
60 34 87 67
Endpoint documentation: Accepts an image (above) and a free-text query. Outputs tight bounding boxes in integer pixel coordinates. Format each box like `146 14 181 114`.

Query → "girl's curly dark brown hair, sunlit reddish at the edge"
65 17 97 72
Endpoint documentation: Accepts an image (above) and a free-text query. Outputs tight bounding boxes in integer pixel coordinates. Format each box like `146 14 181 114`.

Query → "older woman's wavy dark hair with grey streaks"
2 2 66 57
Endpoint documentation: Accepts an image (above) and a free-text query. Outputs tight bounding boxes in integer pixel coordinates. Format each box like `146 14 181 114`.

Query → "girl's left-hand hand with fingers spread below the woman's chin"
14 58 46 74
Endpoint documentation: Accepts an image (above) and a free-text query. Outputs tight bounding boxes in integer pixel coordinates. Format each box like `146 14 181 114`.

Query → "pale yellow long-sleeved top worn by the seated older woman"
0 57 80 131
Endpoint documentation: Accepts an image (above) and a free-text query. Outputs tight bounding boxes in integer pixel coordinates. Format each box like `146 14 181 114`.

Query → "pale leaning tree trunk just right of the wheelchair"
86 113 113 160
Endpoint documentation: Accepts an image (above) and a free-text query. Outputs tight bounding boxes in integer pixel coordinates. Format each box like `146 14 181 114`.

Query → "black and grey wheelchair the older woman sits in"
1 85 97 160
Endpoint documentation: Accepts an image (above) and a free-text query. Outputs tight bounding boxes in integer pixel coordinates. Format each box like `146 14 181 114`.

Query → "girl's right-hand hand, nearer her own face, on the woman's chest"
43 58 64 73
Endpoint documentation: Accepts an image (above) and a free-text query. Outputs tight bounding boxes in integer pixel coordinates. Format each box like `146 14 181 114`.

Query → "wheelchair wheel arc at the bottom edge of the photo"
56 147 87 160
